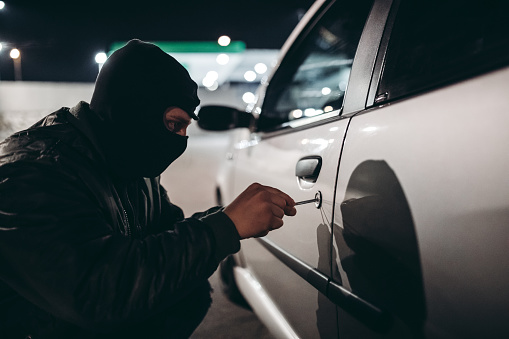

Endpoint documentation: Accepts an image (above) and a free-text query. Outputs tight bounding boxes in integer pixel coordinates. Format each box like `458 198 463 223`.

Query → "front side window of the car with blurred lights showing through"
258 0 373 130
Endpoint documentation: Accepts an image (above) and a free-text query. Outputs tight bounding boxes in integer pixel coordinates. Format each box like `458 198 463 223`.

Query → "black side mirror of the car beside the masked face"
198 106 254 131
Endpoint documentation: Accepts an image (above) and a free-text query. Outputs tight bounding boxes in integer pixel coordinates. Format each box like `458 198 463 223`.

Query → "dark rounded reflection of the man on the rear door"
335 160 426 334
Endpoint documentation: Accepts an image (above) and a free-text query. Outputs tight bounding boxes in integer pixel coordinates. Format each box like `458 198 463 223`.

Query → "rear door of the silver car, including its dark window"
329 0 509 338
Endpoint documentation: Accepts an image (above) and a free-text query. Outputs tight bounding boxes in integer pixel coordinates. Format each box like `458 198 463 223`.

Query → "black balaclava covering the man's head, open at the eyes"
90 40 200 180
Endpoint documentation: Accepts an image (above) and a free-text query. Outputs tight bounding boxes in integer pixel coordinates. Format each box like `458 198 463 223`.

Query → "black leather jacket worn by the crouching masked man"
0 102 240 338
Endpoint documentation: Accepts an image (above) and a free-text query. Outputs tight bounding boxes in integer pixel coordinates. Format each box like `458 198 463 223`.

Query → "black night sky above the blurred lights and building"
0 0 313 82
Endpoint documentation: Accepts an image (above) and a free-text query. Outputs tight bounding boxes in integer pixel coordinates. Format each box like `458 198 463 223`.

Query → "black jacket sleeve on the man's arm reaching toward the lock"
0 162 240 331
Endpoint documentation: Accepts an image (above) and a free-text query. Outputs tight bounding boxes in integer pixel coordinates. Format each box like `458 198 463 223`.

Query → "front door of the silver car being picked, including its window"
225 0 372 338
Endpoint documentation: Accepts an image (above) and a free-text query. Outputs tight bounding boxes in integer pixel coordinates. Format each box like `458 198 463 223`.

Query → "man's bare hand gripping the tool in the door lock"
224 183 297 239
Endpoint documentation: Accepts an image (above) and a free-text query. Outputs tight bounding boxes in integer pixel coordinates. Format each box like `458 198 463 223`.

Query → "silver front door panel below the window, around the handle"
233 119 348 338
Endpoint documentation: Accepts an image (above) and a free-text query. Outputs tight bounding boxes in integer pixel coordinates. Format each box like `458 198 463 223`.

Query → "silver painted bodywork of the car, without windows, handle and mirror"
204 0 509 338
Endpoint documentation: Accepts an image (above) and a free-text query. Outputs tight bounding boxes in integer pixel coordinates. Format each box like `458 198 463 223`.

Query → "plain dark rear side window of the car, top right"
377 0 509 100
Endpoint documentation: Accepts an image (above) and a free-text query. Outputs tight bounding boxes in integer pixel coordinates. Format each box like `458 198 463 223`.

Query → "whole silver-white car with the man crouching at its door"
199 0 509 338
